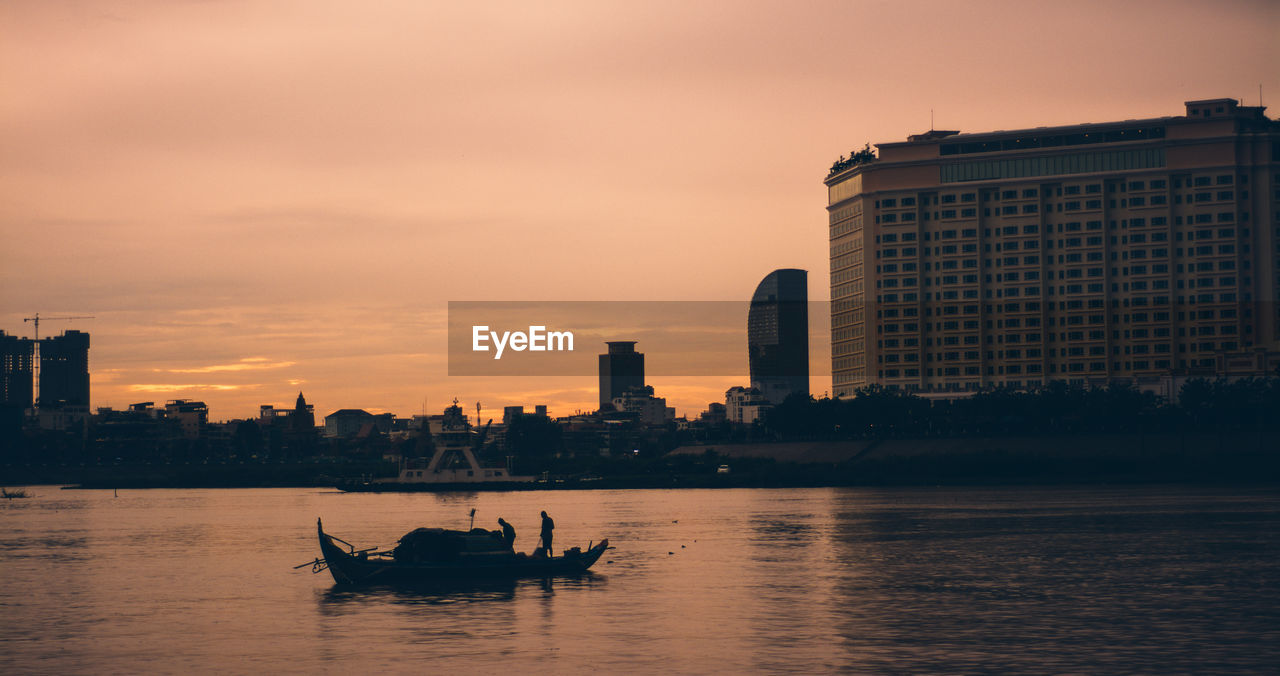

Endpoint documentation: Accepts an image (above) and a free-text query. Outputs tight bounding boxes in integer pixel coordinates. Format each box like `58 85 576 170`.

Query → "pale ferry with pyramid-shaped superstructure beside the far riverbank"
337 399 536 493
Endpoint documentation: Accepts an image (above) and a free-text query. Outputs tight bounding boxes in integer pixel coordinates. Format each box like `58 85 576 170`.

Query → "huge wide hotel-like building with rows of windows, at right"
826 99 1280 394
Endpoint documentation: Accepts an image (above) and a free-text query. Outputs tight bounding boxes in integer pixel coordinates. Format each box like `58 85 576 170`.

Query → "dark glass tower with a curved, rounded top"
746 269 809 403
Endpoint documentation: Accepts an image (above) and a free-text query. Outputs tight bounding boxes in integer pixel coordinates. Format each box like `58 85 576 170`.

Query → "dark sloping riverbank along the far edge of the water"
0 434 1280 490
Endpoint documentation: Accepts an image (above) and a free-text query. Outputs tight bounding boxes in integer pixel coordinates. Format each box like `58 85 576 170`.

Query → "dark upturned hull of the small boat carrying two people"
316 520 609 585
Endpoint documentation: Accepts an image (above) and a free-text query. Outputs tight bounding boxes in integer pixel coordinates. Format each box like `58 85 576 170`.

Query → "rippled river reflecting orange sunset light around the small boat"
0 487 1280 673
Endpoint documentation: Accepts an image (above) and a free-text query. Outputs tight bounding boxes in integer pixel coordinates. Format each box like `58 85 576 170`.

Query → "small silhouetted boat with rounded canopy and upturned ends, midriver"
308 519 609 585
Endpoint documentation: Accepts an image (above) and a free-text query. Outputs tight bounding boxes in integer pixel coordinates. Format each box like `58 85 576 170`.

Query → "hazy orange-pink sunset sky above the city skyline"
0 0 1280 420
